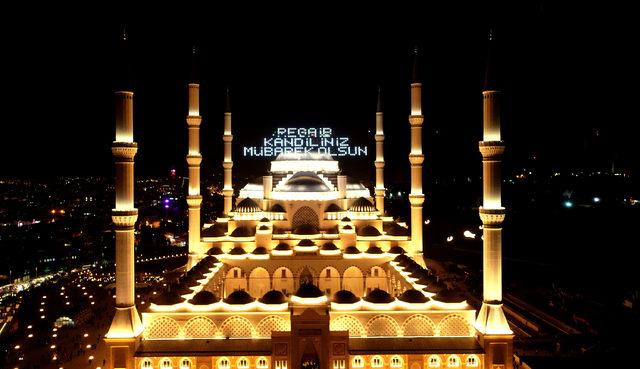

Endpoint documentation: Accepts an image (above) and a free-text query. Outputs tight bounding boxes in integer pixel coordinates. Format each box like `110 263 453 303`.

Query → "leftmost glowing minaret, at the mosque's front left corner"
105 29 143 367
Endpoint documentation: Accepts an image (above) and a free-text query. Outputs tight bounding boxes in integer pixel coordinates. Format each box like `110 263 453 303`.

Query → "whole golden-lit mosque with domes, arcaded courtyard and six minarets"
105 32 513 369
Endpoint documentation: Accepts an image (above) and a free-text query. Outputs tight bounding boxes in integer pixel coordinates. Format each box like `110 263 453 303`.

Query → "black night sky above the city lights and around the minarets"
0 1 640 178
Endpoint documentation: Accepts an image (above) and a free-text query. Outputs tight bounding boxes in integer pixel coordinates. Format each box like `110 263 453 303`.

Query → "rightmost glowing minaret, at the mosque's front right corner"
475 31 513 368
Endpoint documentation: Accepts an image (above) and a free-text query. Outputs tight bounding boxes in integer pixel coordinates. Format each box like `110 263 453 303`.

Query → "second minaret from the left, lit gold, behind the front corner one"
187 47 202 253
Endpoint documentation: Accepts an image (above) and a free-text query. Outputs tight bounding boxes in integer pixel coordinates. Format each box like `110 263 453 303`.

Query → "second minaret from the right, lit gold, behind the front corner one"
409 47 424 255
